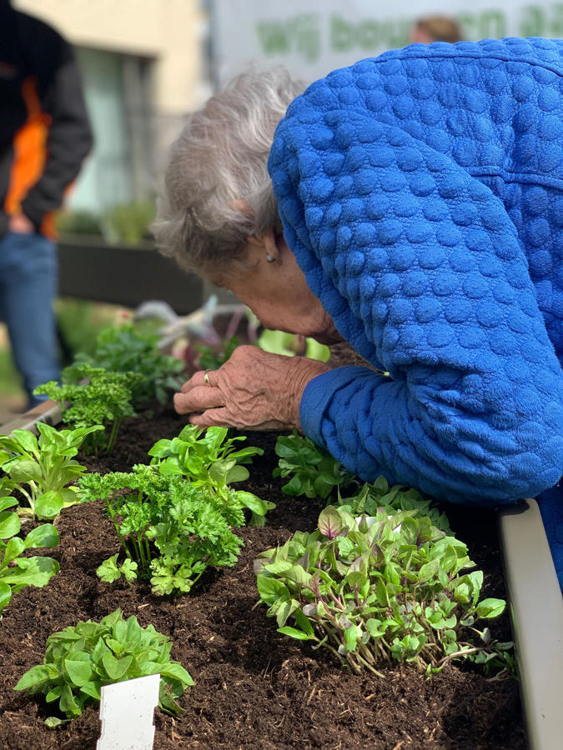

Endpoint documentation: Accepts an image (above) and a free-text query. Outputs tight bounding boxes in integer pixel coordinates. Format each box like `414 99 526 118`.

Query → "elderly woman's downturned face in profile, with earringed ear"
208 231 342 344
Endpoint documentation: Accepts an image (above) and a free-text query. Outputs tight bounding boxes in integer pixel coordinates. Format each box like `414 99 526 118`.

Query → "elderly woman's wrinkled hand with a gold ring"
174 346 329 430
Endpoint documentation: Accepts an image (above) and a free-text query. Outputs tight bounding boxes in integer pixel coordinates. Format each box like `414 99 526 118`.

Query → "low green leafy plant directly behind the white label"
15 609 194 726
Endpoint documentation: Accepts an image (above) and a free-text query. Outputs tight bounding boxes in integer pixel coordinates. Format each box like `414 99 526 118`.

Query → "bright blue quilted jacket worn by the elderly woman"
269 39 563 580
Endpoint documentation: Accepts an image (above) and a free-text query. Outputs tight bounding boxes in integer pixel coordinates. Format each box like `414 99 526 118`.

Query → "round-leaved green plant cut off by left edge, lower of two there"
0 496 59 613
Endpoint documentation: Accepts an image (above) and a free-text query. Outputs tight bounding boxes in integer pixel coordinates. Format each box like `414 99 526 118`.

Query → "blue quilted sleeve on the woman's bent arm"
269 111 563 507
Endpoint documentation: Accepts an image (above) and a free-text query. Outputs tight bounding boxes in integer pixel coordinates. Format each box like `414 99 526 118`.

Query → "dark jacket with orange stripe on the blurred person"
0 0 92 236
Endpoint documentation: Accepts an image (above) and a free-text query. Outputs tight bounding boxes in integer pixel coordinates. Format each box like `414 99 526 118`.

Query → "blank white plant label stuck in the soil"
97 674 160 750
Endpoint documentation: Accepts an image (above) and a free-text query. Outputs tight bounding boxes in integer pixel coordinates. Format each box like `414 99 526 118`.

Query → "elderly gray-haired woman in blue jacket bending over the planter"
155 39 563 588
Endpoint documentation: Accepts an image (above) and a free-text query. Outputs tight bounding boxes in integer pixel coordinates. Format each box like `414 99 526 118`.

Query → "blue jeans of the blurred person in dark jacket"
0 232 60 407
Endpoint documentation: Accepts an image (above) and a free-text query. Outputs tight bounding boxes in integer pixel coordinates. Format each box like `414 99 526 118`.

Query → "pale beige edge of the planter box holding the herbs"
1 401 563 750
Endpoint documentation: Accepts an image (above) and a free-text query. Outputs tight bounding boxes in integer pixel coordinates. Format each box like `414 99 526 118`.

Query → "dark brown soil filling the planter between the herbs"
0 409 526 750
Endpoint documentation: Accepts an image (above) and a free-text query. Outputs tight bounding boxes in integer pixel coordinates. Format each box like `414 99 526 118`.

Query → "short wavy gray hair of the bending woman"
152 67 305 274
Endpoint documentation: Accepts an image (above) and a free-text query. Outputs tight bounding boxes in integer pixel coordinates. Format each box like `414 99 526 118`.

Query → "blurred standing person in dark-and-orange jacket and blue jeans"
0 0 92 407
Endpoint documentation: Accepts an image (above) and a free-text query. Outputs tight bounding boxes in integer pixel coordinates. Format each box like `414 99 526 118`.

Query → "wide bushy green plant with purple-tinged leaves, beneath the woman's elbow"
255 506 513 676
